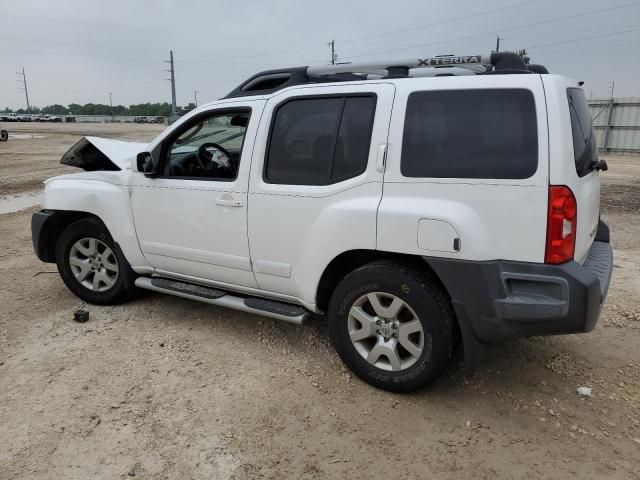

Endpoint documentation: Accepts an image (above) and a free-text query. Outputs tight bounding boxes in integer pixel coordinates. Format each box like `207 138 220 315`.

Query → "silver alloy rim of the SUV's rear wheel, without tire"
347 292 425 372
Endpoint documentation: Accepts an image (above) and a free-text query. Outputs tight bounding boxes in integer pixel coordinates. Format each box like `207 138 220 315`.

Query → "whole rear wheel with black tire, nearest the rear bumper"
328 261 455 392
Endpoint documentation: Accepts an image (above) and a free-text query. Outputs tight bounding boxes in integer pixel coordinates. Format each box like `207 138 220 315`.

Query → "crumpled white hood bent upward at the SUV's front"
60 137 148 172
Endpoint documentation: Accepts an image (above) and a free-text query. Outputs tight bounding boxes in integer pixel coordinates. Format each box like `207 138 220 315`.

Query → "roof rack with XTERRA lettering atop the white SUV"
224 52 549 98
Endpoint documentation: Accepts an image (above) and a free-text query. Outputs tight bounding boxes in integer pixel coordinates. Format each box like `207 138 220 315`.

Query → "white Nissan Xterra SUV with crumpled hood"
32 53 612 391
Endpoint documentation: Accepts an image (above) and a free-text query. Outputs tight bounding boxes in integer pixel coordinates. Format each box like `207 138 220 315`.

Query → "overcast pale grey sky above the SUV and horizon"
0 0 640 109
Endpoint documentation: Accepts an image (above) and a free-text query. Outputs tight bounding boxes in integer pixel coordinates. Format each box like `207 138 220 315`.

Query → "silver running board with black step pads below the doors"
136 277 310 325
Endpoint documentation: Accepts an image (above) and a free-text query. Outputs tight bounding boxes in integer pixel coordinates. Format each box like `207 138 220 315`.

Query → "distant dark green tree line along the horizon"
2 102 171 117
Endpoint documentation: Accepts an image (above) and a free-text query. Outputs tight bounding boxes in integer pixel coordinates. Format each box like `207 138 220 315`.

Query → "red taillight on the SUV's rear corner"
544 185 578 264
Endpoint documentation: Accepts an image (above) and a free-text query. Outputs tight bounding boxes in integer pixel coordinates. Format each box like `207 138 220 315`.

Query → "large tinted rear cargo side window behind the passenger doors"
400 89 538 179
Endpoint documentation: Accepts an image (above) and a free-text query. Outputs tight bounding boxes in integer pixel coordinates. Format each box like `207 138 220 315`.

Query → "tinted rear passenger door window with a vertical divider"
264 95 376 185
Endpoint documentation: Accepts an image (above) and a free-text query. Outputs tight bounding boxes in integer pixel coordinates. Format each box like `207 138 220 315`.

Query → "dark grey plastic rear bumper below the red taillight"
425 224 613 342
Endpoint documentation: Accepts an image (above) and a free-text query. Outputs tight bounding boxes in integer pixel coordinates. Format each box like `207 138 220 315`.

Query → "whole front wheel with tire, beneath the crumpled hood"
56 218 136 305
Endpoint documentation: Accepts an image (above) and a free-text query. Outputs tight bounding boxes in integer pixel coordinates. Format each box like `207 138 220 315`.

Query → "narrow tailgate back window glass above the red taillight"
567 88 598 177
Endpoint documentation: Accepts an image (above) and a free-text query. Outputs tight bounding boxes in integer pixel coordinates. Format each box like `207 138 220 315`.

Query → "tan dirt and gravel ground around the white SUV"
0 124 640 479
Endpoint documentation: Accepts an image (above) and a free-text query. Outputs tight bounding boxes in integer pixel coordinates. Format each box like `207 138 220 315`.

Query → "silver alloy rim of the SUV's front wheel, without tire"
69 238 119 292
